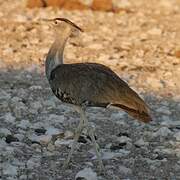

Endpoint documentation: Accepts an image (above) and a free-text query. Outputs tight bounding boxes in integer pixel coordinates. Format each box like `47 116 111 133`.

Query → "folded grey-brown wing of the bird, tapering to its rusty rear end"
50 63 151 122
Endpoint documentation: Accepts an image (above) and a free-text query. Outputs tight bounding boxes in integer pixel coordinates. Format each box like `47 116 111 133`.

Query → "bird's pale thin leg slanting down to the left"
63 114 84 169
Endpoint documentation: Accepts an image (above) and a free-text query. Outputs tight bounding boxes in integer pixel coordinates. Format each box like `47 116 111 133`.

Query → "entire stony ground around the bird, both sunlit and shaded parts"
0 0 180 180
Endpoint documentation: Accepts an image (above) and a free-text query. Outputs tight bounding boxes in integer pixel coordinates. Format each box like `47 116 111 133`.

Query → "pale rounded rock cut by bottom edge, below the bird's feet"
75 168 97 180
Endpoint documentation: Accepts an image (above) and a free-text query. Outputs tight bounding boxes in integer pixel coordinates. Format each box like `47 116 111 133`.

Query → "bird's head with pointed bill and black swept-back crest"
46 18 83 36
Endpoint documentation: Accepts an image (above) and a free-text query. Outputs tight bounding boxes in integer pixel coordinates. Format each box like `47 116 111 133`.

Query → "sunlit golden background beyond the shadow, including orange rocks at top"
0 0 180 96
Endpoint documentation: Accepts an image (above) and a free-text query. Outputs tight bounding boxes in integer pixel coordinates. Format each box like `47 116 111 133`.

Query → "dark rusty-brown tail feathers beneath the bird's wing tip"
112 104 152 123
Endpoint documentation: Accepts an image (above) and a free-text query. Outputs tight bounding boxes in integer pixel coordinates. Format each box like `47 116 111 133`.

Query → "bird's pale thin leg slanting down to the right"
80 109 105 171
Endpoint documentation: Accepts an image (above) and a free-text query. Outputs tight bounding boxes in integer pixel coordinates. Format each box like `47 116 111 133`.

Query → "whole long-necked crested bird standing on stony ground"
45 17 152 170
